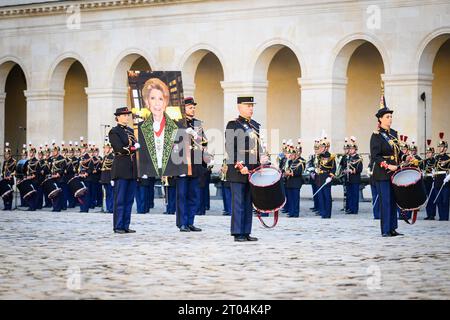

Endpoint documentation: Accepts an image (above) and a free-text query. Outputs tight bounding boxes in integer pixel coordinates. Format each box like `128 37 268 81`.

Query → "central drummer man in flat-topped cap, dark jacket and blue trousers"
225 97 268 242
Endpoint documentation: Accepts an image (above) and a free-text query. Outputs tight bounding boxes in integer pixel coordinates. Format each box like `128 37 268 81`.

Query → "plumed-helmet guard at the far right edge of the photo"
430 132 450 221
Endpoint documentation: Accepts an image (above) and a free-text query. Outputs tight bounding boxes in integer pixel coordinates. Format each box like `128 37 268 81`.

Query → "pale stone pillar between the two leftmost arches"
24 90 64 145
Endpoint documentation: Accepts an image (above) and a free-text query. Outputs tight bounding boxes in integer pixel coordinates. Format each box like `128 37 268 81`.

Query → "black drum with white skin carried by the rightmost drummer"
391 167 427 211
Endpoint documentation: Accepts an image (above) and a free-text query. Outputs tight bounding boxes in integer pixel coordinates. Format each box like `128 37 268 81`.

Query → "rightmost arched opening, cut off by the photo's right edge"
429 36 450 144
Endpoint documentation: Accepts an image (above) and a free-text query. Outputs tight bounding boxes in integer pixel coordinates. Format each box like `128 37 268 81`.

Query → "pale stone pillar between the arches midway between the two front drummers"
299 78 347 156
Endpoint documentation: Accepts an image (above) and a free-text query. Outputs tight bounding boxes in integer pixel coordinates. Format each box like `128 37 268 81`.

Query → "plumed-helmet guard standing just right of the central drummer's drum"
283 142 306 218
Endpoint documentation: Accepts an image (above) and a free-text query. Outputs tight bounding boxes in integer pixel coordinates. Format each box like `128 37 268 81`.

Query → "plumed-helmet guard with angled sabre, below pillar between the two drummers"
316 136 336 219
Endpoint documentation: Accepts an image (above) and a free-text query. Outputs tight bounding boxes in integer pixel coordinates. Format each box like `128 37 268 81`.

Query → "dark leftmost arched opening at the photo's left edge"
4 64 27 156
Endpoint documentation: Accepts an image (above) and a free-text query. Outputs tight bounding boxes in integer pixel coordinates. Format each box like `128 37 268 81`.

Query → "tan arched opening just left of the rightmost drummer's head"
344 42 389 153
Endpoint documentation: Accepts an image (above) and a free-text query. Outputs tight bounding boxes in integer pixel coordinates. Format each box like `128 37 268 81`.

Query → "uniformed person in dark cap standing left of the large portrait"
109 107 140 233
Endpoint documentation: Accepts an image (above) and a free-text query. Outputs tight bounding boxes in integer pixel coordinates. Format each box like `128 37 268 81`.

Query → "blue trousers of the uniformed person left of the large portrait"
113 179 136 230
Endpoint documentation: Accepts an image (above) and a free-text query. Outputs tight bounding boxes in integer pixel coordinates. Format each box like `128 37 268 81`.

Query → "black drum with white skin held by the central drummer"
249 166 286 213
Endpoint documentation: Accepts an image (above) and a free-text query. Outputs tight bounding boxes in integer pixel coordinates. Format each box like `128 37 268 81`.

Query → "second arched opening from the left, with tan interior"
63 61 88 141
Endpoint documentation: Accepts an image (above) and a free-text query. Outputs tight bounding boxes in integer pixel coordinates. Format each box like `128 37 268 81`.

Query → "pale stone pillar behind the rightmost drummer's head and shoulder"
382 74 436 152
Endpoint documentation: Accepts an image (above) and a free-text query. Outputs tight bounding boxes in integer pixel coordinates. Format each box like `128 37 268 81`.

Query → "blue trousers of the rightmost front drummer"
376 180 398 234
